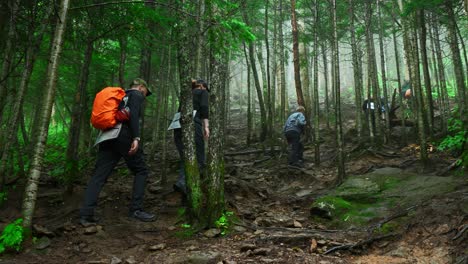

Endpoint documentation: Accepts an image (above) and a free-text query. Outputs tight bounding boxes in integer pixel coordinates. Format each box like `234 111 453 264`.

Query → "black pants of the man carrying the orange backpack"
80 127 148 216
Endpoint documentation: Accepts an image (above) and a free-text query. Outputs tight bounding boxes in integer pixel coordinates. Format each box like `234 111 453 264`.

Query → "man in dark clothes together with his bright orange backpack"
80 78 155 226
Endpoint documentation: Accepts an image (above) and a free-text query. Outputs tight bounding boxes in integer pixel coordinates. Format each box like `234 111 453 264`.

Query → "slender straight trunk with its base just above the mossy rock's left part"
333 0 346 184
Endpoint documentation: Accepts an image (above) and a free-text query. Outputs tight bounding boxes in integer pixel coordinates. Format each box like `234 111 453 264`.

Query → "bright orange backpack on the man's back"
91 87 125 130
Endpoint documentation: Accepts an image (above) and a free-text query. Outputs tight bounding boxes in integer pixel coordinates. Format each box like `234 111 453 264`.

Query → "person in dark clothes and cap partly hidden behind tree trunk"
169 79 210 199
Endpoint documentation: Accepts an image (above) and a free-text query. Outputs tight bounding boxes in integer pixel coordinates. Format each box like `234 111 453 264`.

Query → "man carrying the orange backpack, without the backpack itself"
80 78 155 226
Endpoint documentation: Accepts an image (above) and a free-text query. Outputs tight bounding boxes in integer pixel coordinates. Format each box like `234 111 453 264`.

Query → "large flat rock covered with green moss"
310 168 458 230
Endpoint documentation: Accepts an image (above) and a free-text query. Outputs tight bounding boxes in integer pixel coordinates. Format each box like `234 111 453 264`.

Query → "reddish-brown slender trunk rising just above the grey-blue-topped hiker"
291 0 309 108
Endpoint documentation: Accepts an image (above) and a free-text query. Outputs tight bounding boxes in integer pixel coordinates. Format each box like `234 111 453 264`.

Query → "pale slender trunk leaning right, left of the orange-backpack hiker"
22 0 70 228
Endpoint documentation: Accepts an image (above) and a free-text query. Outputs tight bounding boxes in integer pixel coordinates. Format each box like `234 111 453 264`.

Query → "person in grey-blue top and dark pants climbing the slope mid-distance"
283 106 306 168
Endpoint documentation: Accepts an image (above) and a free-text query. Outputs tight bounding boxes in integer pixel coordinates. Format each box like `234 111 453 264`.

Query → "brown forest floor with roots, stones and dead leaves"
0 105 468 264
